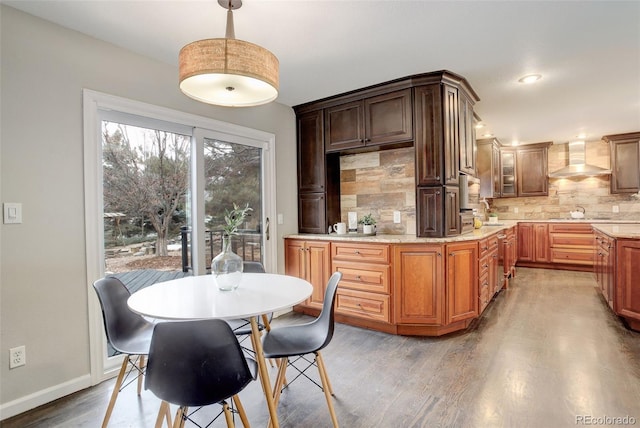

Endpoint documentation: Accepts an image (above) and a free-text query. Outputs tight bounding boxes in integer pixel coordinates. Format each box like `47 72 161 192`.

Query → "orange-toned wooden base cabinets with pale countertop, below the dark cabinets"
285 221 517 336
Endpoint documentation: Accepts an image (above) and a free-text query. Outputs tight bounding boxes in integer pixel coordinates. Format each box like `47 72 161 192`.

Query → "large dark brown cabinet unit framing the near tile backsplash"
294 71 479 237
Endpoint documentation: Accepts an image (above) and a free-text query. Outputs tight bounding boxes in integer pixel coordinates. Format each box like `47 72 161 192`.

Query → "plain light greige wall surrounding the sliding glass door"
0 5 297 419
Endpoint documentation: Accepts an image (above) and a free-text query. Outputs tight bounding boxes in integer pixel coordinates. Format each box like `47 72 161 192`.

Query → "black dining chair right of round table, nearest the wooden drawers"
262 272 342 427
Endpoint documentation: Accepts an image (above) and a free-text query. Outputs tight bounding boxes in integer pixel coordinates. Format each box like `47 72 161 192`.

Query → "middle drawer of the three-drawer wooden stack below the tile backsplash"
333 261 391 294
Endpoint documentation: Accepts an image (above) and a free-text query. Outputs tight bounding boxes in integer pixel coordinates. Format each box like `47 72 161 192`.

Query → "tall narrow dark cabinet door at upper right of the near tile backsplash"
413 84 444 186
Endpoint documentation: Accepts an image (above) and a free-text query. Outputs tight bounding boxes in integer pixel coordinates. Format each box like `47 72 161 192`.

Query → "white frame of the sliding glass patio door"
82 89 278 385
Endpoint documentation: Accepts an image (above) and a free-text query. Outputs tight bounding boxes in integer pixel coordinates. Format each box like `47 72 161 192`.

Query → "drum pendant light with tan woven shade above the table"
179 0 279 107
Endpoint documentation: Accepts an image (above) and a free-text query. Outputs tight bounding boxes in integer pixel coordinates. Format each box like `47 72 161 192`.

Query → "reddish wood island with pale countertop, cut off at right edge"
592 223 640 331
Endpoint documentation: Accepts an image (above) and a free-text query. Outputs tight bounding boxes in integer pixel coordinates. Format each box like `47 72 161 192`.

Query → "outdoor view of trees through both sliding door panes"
102 121 262 272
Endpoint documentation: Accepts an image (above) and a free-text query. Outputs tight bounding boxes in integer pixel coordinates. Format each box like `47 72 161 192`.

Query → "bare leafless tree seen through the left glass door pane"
103 123 190 256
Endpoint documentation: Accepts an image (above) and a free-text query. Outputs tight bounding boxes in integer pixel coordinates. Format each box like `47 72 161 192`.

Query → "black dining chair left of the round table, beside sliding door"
93 277 154 428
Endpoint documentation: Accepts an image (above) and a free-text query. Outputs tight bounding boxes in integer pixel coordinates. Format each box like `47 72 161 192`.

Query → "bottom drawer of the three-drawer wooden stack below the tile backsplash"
336 287 391 322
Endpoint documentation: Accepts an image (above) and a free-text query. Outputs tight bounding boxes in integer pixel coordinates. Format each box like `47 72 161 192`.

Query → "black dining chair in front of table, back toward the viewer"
145 319 257 428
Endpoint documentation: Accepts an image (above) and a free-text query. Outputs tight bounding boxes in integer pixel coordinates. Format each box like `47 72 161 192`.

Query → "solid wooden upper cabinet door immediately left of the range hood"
516 147 549 196
